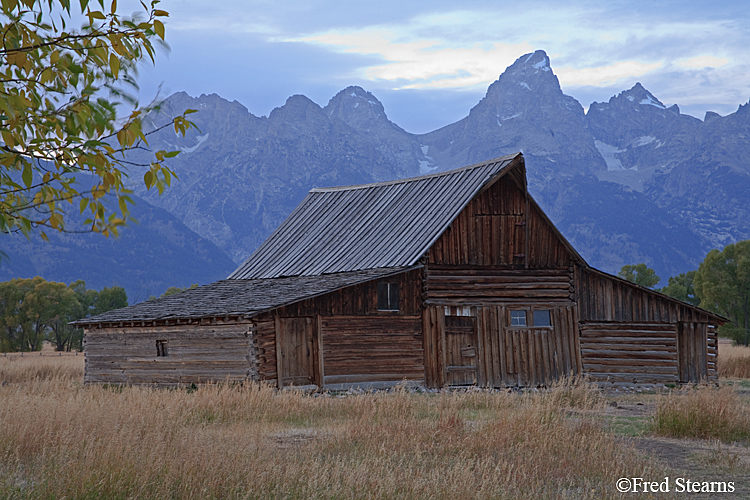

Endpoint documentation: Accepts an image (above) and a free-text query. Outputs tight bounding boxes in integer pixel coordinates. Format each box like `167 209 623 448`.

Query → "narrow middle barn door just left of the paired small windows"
445 316 477 385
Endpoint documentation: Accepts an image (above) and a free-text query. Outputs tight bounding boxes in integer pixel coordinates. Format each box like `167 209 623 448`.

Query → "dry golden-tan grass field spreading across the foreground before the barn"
0 344 750 499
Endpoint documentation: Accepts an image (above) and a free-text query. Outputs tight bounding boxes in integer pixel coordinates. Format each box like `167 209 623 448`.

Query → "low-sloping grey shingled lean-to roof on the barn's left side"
71 266 419 326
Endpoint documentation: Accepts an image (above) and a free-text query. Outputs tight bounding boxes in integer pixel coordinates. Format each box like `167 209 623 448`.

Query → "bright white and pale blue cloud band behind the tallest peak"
285 2 746 95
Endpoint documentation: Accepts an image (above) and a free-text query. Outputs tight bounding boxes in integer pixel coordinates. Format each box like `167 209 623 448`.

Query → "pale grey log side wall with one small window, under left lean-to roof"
84 323 258 385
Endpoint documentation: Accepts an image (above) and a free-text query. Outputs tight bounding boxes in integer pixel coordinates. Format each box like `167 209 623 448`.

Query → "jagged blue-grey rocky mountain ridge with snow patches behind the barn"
7 51 750 292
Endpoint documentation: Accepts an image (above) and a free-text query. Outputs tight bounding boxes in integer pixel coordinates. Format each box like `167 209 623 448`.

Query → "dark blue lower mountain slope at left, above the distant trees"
0 192 234 304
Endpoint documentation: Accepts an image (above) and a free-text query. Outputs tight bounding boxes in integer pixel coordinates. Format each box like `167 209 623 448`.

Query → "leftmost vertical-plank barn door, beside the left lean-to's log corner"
276 317 317 386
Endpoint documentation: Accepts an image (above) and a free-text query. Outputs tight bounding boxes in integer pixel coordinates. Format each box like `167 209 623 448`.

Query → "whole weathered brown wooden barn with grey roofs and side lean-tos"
73 154 723 388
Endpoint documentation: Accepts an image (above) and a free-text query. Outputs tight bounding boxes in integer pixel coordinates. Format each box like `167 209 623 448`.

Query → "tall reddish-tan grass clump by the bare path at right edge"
653 387 750 442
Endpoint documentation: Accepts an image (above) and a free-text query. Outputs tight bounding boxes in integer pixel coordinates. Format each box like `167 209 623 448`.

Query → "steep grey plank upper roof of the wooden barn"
229 154 523 279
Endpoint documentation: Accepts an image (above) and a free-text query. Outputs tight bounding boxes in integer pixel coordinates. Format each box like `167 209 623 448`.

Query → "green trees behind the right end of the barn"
618 240 750 345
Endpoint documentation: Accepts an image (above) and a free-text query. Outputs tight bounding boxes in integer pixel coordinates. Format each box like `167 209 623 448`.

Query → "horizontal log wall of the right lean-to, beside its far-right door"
580 322 679 384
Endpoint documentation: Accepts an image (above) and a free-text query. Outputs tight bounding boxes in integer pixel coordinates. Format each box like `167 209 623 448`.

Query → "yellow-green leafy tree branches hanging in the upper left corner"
0 0 192 239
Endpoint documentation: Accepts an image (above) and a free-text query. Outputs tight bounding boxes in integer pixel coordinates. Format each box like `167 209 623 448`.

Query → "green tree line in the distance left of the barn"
0 276 128 352
